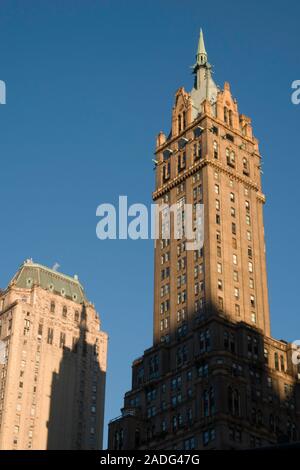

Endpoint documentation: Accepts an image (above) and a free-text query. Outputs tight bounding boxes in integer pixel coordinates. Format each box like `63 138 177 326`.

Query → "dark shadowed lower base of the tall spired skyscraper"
109 313 300 450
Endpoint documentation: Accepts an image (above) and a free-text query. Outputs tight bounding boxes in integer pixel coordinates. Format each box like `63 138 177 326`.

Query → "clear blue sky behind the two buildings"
0 0 300 448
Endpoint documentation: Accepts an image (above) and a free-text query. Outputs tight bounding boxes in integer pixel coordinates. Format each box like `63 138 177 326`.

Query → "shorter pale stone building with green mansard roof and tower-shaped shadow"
0 260 107 450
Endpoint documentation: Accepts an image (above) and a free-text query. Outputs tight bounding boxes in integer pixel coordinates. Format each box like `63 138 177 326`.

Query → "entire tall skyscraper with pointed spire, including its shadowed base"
109 32 300 450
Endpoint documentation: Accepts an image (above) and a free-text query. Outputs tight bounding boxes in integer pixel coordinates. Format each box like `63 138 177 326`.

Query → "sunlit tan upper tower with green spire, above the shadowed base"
153 31 270 343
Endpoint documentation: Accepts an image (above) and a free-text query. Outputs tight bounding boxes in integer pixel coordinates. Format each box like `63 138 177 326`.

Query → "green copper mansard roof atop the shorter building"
10 260 87 304
